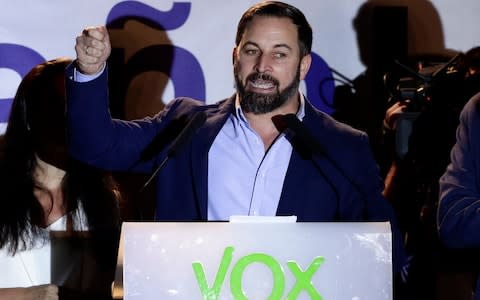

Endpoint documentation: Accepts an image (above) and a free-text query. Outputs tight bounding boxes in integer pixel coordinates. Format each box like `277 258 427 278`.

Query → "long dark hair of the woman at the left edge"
0 58 120 268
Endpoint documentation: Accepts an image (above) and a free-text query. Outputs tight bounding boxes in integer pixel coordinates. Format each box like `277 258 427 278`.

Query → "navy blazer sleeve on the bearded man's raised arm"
66 63 177 172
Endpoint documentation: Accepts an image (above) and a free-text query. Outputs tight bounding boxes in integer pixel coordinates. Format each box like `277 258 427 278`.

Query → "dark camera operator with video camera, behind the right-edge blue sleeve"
384 47 480 299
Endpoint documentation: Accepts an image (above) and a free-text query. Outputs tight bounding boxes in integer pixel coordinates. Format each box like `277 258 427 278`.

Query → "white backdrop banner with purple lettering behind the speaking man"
0 0 480 131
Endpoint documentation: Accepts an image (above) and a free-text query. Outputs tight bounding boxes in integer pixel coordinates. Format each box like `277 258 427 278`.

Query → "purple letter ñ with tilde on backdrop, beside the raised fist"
107 1 205 101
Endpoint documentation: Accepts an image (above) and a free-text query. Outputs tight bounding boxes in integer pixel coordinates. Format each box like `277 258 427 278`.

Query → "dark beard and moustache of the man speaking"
235 68 300 115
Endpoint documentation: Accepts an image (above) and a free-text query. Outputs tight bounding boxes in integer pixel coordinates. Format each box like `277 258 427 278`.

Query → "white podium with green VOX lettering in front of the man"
114 222 393 300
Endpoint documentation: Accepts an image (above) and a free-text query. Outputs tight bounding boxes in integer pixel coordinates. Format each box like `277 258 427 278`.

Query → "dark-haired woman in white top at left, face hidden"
0 58 120 300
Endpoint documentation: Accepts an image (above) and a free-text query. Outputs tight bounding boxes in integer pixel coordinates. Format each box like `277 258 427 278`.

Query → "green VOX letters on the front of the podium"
192 247 325 300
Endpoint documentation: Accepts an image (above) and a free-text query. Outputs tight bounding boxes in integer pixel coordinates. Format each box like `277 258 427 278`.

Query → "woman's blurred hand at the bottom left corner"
0 284 59 300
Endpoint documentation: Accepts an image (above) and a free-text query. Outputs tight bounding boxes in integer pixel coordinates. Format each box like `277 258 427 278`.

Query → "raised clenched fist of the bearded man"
75 26 112 75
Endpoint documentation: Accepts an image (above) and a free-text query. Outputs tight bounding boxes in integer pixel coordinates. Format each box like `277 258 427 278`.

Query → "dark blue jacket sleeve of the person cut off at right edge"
437 94 480 248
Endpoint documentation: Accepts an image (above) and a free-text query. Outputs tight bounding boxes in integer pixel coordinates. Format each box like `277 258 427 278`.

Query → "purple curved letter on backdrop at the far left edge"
0 43 45 123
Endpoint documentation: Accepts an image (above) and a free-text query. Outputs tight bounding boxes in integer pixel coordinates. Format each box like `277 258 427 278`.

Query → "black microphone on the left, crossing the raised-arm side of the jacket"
141 111 207 191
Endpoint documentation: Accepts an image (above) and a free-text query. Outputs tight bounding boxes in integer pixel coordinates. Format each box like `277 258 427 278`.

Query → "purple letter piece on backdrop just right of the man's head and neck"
305 53 335 114
